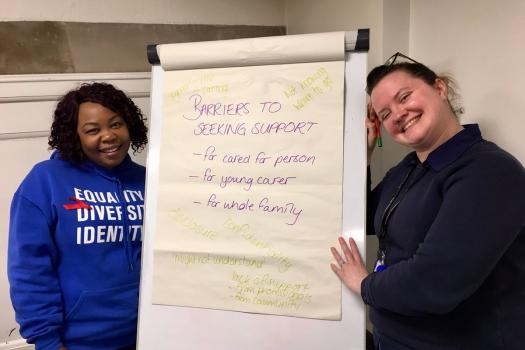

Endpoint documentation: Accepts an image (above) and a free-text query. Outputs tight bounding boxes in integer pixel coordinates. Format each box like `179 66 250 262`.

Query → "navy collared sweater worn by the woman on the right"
361 125 525 350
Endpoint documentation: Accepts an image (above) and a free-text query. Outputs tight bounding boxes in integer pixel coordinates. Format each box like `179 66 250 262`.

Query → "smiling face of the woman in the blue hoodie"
77 102 130 169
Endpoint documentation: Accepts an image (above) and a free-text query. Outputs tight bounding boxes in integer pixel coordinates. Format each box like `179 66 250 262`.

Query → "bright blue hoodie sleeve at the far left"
8 193 63 350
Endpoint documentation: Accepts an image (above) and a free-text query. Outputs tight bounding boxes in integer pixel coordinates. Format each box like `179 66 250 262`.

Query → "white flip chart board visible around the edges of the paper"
138 30 368 350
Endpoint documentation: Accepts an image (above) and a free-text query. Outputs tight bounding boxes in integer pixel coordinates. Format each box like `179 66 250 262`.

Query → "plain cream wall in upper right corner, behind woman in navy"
410 0 525 164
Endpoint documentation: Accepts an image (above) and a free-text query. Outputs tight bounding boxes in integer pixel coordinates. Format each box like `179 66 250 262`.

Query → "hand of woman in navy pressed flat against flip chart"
330 237 368 295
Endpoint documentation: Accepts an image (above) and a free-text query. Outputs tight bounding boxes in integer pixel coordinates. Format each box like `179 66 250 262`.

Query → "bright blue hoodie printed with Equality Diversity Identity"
8 152 145 350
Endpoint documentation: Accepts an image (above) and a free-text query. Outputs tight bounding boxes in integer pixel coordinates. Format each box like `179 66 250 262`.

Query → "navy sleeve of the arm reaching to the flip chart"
361 152 525 316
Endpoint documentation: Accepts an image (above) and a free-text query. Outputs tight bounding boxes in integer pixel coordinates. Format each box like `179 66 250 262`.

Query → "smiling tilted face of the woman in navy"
370 70 462 160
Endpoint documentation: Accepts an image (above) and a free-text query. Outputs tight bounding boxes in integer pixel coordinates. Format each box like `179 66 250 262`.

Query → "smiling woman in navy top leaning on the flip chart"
332 54 525 350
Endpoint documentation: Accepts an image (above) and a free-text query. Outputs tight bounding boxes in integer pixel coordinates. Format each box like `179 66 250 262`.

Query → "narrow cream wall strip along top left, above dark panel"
0 0 284 26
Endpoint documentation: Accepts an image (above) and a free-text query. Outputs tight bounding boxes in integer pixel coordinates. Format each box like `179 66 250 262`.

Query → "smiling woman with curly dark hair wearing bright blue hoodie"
8 83 147 350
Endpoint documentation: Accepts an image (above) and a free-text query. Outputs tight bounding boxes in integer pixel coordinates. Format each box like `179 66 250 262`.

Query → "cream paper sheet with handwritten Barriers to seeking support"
153 32 344 319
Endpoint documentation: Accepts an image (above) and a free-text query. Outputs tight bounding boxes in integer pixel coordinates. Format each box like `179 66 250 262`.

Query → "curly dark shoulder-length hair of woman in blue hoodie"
48 83 148 164
